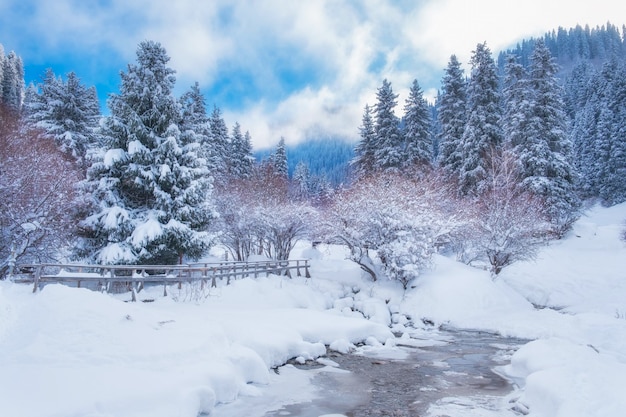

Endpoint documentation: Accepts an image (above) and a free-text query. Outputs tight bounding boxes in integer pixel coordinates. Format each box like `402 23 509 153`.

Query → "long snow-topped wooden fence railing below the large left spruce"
11 259 311 301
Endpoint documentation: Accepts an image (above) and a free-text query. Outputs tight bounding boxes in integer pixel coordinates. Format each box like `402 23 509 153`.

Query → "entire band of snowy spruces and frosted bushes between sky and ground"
0 24 626 282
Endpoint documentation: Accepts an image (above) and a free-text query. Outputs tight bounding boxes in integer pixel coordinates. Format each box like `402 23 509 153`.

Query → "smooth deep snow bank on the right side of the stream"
402 204 626 417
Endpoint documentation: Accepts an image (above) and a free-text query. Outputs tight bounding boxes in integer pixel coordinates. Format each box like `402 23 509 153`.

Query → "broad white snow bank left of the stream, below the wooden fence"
0 277 392 417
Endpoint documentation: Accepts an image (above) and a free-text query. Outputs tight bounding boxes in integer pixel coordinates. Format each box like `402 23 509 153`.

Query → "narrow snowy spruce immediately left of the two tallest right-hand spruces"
437 55 467 177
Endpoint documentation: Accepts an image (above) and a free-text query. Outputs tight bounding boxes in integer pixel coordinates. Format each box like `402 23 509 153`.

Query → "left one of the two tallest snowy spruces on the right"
459 43 503 195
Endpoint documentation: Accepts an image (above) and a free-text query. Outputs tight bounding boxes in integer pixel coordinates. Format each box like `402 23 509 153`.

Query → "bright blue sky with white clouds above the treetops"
0 0 626 148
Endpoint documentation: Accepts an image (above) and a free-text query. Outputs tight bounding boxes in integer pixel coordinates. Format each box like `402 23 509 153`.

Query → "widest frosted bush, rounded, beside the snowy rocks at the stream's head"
323 173 458 288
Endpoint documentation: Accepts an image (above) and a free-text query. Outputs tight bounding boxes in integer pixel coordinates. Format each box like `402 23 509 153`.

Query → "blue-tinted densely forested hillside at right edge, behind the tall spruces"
498 23 626 205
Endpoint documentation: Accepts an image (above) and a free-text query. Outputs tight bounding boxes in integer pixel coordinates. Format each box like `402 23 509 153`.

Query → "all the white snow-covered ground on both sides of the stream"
0 204 626 417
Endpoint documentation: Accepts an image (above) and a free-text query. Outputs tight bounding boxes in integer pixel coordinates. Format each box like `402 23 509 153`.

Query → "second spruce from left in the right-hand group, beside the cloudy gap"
373 79 403 171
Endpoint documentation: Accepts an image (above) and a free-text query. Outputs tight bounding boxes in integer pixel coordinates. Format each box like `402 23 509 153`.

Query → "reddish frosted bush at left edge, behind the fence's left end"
0 109 81 278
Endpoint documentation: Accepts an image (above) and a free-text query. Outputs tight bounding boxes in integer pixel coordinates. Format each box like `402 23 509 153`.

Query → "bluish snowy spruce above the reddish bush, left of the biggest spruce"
25 69 100 169
